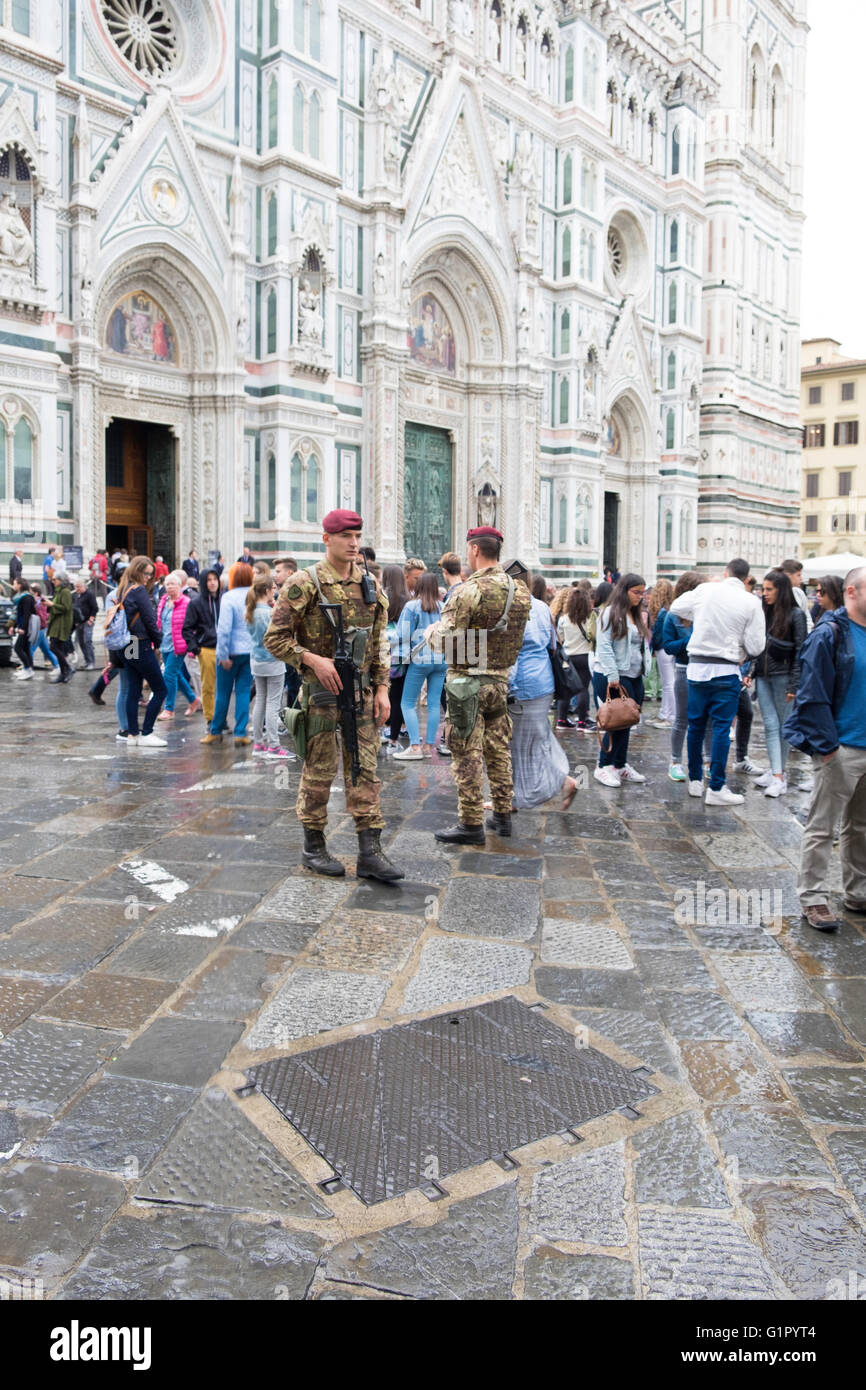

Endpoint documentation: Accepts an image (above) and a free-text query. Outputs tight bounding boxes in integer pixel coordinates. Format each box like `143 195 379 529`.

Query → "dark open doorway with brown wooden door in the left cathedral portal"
106 420 178 567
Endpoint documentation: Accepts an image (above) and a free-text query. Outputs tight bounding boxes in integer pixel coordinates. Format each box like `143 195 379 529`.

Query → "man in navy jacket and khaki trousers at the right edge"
783 564 866 931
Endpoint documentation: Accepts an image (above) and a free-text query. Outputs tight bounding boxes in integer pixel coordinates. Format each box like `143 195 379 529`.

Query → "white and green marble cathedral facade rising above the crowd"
0 0 806 580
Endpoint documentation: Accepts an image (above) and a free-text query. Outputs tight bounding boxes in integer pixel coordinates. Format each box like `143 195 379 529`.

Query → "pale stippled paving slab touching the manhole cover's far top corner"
400 937 532 1013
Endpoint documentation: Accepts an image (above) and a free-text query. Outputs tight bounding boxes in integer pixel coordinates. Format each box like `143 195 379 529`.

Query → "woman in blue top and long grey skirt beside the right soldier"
509 571 577 810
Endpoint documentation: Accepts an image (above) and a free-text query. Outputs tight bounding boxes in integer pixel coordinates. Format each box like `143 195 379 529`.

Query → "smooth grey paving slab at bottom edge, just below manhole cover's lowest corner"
324 1183 517 1302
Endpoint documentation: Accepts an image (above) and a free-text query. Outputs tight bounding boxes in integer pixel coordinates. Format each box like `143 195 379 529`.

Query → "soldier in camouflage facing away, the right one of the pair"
428 527 530 845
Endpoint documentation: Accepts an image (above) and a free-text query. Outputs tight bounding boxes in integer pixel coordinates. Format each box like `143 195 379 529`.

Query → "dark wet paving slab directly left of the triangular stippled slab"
35 1076 196 1179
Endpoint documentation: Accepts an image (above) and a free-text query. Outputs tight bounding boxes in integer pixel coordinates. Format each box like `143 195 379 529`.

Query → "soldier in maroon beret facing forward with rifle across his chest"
264 510 403 881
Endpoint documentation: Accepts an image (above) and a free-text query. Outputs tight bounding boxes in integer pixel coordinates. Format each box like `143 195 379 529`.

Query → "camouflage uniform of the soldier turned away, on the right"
434 564 530 826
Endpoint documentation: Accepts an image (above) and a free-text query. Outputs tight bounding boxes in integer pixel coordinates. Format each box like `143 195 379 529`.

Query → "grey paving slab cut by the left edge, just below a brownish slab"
0 1019 124 1115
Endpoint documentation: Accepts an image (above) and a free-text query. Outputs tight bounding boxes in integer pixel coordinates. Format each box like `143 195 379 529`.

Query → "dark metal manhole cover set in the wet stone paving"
247 997 656 1205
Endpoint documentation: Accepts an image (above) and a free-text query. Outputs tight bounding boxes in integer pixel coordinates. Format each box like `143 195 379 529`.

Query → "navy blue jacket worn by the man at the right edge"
781 607 853 758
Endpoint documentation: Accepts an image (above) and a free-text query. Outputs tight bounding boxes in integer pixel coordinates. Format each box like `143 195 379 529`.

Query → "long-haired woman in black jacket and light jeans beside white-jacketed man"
746 570 806 796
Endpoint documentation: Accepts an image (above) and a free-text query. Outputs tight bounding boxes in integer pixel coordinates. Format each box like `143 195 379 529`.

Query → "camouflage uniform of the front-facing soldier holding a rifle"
264 560 391 830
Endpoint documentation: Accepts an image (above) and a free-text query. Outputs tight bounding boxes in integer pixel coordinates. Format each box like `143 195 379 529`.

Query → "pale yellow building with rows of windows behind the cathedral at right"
801 338 866 559
